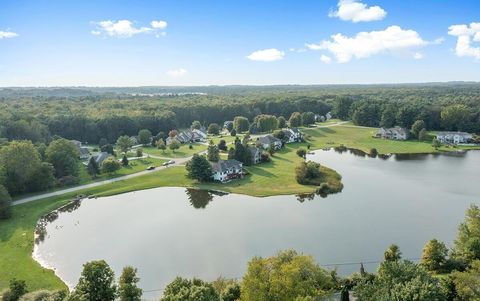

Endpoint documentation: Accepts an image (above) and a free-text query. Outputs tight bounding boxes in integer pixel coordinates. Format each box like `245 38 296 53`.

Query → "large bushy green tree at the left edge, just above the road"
0 141 42 195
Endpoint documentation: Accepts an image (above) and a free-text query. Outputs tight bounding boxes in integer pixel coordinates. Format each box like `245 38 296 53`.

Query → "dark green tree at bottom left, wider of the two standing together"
72 260 117 301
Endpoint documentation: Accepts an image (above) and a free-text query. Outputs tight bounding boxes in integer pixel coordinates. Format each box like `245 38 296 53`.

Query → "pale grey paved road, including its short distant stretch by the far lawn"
12 121 349 206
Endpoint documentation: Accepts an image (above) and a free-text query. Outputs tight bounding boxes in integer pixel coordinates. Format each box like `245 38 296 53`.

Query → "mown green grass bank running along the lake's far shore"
0 124 480 290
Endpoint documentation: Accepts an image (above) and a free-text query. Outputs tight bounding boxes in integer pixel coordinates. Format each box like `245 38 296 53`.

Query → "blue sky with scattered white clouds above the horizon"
0 0 480 86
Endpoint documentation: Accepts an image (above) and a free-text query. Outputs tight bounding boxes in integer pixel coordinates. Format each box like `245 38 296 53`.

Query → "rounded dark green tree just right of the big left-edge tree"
45 138 80 178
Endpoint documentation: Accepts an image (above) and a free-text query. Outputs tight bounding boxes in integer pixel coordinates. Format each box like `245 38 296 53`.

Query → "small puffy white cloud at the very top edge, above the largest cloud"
328 0 387 23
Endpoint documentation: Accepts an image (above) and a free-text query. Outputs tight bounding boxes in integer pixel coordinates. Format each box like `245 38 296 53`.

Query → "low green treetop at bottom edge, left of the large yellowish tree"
160 277 220 301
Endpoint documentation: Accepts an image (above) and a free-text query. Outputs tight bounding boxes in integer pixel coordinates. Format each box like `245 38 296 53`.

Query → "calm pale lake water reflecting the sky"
34 150 480 298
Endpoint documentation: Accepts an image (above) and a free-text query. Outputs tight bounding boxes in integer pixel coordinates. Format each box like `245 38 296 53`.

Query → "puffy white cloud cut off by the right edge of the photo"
448 22 480 60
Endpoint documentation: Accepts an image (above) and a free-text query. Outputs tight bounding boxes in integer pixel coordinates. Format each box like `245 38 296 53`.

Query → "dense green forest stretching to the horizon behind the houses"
0 83 480 144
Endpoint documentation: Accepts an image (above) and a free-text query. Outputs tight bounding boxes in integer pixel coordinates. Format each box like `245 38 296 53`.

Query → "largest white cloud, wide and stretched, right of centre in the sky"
306 26 429 63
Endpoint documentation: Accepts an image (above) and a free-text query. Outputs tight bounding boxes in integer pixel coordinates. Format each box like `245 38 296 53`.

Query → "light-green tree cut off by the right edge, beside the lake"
453 205 480 263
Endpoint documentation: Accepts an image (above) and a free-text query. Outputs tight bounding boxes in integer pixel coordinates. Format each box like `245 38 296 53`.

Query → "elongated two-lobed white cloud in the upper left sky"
91 20 167 38
